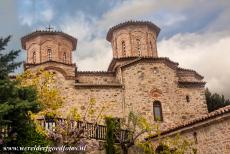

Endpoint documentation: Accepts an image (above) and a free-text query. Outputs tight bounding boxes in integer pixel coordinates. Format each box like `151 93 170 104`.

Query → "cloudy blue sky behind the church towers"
0 0 230 98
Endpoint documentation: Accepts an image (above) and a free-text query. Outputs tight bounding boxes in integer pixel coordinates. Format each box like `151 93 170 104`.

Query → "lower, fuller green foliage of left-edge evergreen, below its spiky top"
0 80 47 145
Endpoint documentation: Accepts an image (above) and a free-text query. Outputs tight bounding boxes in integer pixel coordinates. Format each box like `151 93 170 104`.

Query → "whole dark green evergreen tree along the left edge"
0 36 46 152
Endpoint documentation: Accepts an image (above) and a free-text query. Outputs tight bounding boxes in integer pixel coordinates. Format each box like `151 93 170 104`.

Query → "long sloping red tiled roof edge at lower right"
146 105 230 140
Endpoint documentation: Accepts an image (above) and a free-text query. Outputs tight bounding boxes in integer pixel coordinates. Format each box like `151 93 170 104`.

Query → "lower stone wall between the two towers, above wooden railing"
45 70 123 123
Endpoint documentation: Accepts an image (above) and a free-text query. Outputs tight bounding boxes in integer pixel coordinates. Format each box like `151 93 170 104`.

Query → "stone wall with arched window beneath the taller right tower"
122 62 207 128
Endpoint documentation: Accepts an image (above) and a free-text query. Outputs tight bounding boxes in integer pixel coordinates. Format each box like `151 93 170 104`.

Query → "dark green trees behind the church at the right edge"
205 89 230 112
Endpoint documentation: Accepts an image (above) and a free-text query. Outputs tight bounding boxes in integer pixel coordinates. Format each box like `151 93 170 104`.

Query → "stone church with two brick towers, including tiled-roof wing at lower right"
21 21 230 153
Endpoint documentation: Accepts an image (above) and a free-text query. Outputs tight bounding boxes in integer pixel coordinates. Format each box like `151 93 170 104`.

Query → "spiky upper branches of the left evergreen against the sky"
0 36 21 80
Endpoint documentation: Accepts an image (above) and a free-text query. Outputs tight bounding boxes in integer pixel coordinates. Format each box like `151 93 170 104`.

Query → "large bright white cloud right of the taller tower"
158 32 230 98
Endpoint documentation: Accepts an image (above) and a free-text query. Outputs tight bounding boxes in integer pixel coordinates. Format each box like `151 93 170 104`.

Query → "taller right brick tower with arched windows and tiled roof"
107 21 160 58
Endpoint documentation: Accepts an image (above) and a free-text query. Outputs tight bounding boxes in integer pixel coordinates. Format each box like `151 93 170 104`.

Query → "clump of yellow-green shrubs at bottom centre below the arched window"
106 112 196 154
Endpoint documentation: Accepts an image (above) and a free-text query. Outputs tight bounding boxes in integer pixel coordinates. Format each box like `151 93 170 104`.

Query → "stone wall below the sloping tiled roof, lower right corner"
153 113 230 154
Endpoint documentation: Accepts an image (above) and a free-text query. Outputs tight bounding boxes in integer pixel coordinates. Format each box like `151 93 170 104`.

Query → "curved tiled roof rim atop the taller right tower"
106 21 160 41
